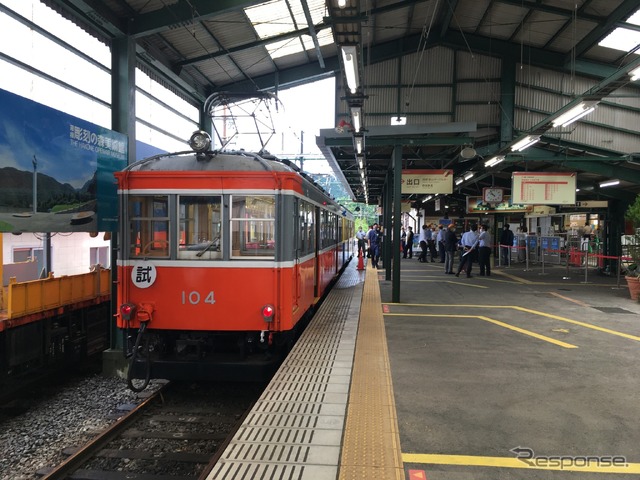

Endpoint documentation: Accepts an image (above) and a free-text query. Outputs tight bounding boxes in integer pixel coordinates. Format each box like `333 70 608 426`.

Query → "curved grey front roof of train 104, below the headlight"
125 150 300 173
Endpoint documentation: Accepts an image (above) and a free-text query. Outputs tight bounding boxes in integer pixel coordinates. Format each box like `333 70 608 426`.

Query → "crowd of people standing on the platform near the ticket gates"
356 223 513 278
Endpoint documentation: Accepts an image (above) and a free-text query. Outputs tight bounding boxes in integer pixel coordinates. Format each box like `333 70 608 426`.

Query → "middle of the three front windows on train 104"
178 196 222 260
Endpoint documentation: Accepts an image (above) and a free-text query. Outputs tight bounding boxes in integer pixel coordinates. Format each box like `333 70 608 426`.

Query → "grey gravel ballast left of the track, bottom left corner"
0 375 159 480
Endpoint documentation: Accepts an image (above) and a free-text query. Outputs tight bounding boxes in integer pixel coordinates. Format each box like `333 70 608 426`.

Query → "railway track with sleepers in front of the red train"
37 382 265 480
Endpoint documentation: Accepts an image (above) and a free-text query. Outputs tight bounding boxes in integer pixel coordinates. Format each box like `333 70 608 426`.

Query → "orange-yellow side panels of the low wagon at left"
0 268 111 319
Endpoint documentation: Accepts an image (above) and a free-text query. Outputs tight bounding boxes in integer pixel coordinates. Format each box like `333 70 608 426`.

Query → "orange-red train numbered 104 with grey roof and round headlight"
116 132 353 389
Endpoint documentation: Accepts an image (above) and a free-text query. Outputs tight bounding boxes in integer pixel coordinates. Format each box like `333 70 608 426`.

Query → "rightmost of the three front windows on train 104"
231 195 276 258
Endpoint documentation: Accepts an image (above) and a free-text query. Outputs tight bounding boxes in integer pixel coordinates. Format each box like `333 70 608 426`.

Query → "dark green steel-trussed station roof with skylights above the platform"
44 0 640 209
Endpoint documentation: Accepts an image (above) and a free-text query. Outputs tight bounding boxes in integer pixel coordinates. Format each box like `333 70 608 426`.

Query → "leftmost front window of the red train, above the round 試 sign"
128 195 169 257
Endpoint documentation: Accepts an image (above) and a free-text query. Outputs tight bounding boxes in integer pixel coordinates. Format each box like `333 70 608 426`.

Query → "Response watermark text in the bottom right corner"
509 447 629 470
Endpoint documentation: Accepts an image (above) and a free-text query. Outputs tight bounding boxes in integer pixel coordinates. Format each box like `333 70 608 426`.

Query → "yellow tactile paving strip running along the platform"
339 267 405 480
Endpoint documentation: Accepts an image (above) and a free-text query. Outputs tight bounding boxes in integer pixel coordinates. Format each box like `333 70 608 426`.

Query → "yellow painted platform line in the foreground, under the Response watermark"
402 453 640 474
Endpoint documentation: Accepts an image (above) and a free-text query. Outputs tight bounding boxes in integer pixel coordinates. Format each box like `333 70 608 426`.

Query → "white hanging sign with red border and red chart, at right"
511 172 577 205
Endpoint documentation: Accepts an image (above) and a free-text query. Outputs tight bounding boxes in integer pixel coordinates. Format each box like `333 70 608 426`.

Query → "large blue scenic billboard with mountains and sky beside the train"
0 90 128 233
